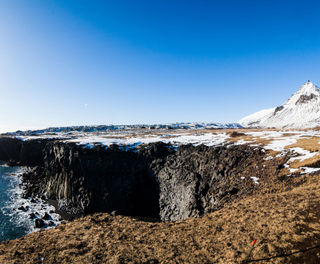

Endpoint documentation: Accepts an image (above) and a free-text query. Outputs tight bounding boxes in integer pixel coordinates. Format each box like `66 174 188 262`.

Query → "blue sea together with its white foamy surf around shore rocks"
0 163 61 241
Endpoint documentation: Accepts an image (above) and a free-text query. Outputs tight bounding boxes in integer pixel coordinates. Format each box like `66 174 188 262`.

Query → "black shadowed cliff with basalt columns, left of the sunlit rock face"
23 142 174 217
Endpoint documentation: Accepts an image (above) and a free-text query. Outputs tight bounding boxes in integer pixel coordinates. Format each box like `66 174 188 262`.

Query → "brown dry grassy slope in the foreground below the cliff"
0 169 320 264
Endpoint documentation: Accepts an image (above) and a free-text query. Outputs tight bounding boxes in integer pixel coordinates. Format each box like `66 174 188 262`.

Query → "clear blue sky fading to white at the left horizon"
0 0 320 131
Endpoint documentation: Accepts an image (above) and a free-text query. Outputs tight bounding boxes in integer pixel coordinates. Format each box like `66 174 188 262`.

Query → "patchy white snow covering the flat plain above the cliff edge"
8 122 320 176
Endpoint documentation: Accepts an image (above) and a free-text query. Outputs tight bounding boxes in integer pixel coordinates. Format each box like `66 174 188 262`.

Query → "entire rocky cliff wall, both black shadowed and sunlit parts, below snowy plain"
0 138 280 221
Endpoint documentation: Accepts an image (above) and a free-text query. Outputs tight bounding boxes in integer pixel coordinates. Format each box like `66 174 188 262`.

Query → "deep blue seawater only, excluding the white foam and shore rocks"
0 164 31 241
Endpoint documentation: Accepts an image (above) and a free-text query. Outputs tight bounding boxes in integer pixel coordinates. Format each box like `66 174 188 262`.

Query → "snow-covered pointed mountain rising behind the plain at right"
239 81 320 128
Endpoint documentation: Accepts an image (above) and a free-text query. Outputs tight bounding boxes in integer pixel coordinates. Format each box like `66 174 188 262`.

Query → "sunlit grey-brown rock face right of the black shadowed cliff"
158 145 262 221
